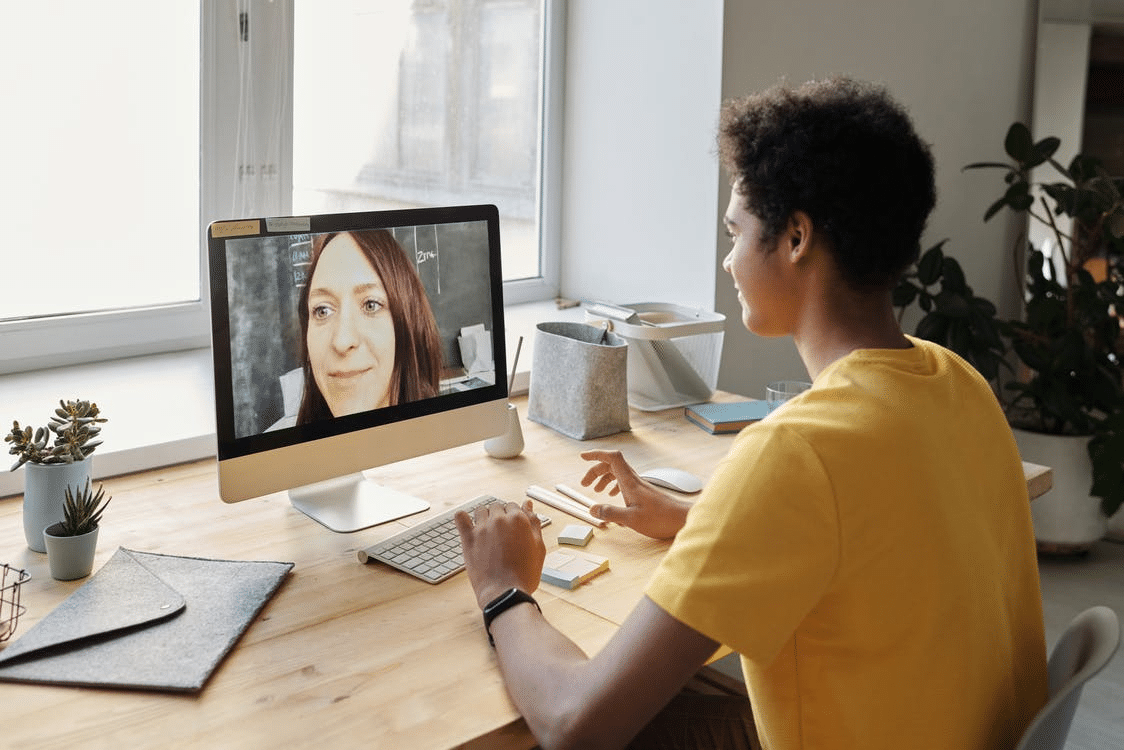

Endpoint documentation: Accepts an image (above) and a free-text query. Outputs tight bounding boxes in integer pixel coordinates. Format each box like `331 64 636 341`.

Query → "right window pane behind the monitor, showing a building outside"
292 0 544 281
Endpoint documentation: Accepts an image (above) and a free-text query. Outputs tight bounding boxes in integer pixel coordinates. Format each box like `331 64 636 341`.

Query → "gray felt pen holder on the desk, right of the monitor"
527 323 629 440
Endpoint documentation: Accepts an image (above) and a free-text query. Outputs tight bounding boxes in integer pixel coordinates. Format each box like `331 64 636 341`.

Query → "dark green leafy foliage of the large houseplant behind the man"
895 123 1124 546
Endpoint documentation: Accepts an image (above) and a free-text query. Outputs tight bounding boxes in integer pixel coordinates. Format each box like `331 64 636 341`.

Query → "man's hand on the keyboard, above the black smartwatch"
455 500 546 609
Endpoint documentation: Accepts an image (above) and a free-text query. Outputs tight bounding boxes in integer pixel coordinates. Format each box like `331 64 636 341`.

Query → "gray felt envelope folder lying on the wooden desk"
0 548 292 690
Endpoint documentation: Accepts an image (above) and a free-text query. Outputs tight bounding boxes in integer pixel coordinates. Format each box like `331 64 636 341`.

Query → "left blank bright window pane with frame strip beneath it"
0 0 207 370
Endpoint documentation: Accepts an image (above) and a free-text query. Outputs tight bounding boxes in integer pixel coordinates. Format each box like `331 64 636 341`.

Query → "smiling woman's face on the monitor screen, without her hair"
307 234 395 417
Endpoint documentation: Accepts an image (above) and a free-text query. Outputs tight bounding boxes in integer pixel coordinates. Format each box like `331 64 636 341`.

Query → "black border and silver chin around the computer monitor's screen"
207 205 508 503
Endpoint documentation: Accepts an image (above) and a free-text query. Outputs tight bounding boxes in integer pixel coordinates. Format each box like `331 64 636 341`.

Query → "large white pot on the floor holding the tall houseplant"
1013 430 1108 554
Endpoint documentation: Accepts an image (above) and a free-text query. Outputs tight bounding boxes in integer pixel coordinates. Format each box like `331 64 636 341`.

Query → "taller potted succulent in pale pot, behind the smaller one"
4 400 106 552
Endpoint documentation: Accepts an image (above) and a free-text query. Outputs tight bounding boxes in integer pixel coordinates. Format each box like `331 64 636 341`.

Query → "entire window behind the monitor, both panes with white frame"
0 0 562 372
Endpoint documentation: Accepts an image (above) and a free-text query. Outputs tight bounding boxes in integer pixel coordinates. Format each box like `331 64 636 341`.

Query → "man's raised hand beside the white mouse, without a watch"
581 451 691 539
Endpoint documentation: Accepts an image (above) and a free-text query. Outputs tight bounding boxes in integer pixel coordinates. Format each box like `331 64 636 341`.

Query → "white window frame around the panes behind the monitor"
0 0 566 373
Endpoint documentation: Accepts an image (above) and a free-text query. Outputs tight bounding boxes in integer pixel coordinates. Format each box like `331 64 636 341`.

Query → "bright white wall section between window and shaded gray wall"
560 0 723 309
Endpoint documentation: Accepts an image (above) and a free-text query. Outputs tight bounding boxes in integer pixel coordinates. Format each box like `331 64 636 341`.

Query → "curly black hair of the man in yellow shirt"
718 78 936 289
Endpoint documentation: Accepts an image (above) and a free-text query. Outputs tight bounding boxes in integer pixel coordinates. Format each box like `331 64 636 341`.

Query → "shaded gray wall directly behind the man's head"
711 0 1036 396
